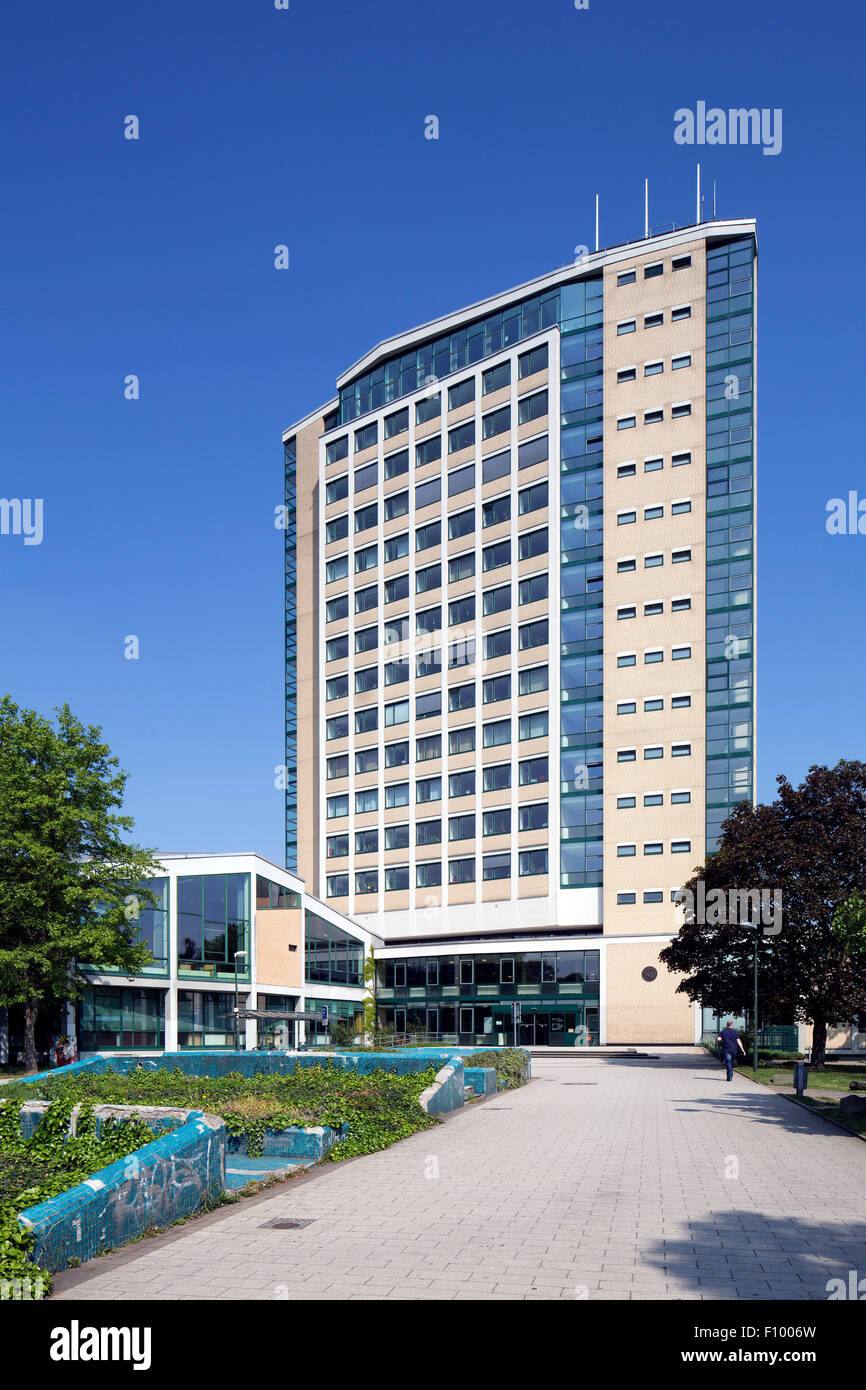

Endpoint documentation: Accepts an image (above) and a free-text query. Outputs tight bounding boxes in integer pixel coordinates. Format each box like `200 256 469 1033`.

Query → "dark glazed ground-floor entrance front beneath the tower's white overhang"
377 949 599 1047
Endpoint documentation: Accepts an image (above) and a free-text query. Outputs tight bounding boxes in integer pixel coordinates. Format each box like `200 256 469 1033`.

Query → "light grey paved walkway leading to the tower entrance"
54 1048 866 1301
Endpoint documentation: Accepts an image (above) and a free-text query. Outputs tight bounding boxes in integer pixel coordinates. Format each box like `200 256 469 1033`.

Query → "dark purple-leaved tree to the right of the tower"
662 762 866 1070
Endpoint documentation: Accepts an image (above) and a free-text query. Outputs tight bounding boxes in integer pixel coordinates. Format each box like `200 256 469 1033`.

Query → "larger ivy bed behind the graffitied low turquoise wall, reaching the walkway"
3 1063 436 1162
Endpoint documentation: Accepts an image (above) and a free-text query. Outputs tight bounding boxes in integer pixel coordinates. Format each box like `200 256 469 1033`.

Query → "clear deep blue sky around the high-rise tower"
0 0 866 862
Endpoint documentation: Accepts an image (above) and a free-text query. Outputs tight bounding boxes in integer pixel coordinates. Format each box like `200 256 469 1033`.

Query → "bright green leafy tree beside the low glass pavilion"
0 695 160 1072
